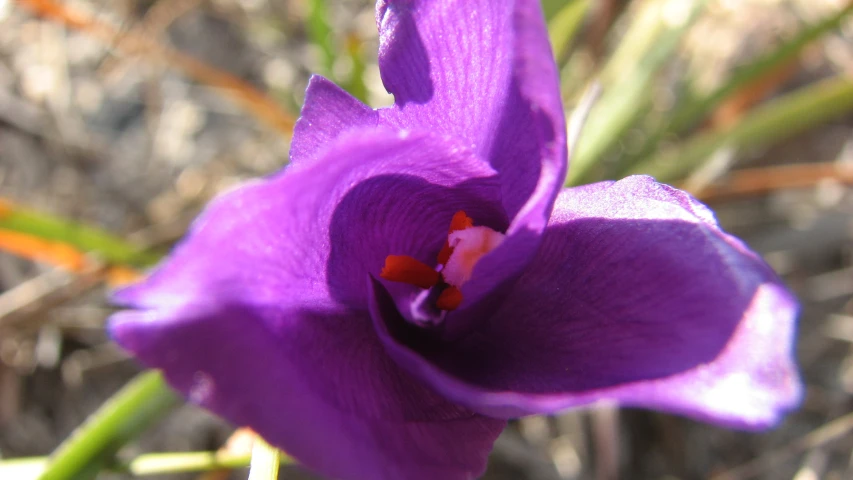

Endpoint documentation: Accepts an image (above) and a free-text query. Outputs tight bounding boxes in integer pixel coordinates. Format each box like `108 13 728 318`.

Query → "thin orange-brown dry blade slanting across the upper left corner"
17 0 295 137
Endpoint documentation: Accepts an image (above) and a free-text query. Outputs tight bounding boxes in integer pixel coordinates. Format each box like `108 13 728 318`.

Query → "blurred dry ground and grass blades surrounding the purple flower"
0 0 853 480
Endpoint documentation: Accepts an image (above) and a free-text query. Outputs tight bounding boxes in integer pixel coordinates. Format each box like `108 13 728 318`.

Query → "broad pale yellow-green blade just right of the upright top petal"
567 0 706 184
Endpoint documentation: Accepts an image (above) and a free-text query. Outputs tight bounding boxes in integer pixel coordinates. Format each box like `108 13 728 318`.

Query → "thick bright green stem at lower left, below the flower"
39 371 178 480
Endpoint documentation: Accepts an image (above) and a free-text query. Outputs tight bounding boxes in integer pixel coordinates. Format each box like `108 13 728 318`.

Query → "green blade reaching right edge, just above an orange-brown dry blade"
628 74 853 182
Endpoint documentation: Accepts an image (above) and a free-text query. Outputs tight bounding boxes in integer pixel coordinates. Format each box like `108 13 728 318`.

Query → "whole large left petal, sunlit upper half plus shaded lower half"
110 129 505 479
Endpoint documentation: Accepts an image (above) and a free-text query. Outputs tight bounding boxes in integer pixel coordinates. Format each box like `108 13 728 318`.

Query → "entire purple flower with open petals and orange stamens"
110 0 800 480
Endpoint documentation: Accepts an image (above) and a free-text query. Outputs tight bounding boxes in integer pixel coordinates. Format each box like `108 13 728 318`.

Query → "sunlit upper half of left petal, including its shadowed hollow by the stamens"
114 130 506 310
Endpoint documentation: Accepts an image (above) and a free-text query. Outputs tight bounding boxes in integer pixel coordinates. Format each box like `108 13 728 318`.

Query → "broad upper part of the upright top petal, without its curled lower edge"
376 0 565 194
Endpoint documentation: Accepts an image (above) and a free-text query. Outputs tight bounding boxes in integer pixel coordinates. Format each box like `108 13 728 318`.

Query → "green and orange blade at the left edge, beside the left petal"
0 200 161 270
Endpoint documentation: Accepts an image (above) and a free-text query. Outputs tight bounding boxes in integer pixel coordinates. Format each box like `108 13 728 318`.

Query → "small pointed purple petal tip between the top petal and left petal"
290 75 379 170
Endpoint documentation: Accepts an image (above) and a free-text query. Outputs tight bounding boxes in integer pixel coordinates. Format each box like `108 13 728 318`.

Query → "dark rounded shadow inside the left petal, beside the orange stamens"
326 175 507 309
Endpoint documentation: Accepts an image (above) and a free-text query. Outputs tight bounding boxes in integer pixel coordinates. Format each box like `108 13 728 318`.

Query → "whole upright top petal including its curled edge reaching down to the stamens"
377 0 566 337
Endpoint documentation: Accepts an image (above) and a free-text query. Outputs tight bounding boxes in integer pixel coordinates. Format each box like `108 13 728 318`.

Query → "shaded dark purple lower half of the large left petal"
110 304 505 480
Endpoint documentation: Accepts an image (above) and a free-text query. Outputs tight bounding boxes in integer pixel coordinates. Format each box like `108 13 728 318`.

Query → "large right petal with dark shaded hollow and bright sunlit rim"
372 177 801 428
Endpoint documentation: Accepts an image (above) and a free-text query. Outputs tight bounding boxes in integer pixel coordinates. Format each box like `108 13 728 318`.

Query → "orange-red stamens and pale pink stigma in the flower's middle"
379 211 504 311
